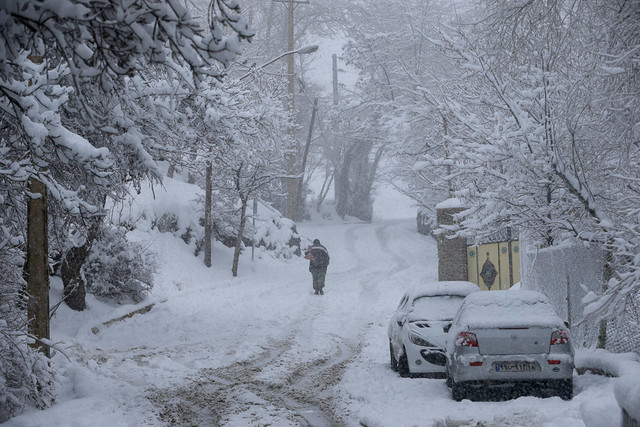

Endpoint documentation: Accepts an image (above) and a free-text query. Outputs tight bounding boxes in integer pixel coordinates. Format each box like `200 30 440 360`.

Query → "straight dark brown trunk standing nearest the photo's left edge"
26 178 51 357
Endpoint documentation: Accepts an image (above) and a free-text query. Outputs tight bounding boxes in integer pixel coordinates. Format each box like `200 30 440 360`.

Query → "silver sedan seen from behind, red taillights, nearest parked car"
446 291 574 401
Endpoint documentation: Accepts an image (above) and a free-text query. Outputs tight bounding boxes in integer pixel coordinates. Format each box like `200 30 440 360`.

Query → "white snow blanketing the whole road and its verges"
6 179 636 427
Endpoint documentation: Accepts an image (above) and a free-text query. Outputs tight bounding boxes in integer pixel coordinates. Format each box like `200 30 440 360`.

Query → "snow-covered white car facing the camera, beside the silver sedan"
388 281 480 378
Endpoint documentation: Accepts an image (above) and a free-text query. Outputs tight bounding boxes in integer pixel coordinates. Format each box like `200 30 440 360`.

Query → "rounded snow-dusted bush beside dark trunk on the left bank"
82 227 155 304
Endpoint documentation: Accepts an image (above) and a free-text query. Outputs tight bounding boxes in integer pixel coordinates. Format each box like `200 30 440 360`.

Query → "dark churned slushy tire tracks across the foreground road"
147 306 363 427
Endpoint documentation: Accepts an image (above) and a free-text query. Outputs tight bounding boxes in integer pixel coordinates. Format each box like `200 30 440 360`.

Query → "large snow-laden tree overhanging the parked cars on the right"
420 0 640 324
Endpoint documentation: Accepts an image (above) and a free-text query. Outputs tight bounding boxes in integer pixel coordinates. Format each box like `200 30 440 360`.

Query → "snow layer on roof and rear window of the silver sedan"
458 291 563 328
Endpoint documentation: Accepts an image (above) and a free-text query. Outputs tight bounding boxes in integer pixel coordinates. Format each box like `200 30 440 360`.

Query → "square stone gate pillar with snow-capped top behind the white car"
436 199 468 281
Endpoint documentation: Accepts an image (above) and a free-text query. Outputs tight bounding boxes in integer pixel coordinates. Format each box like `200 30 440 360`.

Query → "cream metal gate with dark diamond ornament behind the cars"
467 240 520 291
